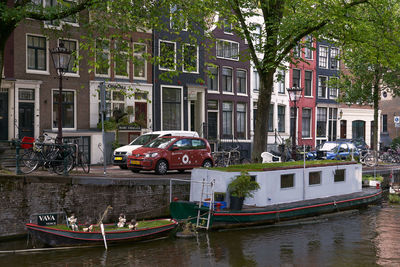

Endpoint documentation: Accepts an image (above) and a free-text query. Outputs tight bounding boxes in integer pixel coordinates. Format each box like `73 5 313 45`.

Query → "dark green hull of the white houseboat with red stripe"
170 190 382 229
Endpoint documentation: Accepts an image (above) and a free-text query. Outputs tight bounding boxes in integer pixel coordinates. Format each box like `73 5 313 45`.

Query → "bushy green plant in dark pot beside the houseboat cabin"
228 172 260 210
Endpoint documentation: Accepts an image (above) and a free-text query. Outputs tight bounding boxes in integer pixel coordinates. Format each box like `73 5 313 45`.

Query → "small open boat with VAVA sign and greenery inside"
26 219 178 247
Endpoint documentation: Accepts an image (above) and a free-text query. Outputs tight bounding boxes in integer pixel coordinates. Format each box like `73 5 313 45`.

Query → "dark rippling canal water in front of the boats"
0 203 400 267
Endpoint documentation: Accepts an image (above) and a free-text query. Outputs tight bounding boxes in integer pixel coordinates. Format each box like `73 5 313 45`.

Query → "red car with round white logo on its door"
127 136 214 174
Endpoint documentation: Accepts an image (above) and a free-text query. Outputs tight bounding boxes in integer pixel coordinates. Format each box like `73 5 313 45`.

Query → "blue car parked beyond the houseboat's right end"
307 140 360 160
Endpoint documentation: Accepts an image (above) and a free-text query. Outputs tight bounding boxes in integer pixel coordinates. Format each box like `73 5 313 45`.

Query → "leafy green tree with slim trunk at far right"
337 0 400 153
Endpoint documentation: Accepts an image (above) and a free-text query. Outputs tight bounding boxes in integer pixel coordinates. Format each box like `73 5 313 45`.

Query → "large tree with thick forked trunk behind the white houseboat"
207 0 374 162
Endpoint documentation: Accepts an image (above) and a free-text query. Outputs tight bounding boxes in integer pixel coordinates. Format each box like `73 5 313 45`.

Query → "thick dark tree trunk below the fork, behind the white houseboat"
251 68 275 163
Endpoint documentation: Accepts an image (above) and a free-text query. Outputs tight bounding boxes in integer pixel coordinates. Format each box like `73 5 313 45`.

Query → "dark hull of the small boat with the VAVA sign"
26 220 178 247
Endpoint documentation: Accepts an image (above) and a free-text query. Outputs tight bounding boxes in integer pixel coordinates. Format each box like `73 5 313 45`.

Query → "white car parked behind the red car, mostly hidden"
113 131 199 169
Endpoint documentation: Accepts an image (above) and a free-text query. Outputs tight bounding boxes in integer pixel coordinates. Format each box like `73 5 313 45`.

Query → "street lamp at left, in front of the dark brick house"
50 43 71 144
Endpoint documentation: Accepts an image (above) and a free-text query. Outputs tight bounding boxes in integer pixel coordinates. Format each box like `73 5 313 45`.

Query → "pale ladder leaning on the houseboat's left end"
196 179 214 230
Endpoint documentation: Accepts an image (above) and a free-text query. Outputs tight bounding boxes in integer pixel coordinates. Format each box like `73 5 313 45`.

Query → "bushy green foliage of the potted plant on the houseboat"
228 172 260 198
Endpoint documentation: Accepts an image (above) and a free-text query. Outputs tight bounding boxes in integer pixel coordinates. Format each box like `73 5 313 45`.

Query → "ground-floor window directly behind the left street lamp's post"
53 90 75 128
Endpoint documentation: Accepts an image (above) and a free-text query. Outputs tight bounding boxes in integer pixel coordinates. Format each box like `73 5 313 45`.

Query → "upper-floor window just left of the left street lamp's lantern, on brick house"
27 35 47 71
